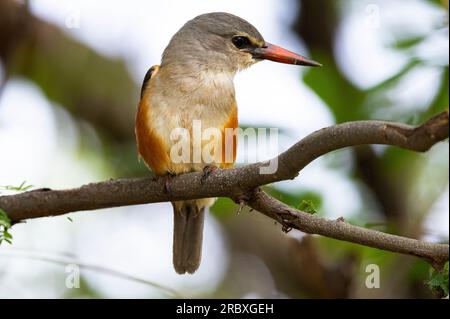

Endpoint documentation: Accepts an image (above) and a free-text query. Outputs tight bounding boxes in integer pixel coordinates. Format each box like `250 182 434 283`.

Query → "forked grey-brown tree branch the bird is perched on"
0 111 449 264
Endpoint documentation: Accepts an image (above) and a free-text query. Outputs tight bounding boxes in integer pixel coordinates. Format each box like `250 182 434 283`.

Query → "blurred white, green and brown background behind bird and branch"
0 0 449 298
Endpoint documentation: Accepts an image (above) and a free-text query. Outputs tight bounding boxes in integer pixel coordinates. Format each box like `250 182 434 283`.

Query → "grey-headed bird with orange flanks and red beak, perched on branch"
135 12 321 274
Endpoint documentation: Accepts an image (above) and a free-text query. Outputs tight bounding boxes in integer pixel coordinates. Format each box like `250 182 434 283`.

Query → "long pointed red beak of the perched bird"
250 42 322 66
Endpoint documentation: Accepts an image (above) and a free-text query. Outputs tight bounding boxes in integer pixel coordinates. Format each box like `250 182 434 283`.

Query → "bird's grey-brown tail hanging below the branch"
172 201 205 274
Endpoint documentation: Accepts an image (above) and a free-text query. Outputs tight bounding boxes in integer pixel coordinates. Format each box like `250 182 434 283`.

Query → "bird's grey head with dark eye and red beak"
161 12 320 72
